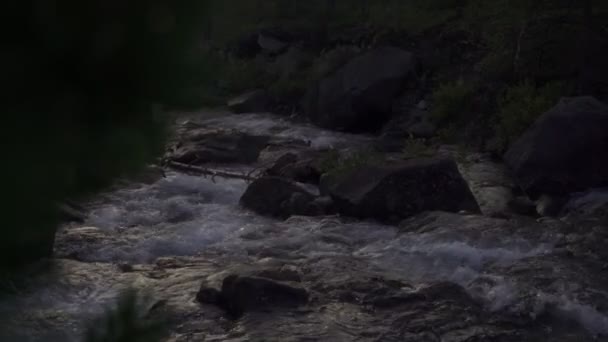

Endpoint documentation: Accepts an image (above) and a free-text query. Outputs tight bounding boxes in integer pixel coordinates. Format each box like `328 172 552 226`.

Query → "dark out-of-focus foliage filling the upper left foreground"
0 0 205 267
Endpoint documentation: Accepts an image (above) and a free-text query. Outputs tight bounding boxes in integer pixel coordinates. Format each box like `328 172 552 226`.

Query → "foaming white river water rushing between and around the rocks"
0 113 608 342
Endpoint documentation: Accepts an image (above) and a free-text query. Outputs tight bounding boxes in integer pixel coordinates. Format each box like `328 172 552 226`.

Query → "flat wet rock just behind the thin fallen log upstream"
166 129 270 165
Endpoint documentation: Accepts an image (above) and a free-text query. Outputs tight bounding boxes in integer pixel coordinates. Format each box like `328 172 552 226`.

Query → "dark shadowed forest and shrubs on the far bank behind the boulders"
193 0 608 151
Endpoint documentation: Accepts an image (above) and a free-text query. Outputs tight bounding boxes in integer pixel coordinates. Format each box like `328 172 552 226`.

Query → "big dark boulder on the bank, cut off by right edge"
505 97 608 199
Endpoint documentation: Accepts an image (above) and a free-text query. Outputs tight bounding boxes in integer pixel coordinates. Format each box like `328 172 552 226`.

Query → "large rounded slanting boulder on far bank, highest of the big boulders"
303 47 416 132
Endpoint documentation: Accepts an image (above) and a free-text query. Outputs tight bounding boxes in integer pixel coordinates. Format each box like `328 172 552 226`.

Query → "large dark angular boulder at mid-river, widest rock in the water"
324 158 480 223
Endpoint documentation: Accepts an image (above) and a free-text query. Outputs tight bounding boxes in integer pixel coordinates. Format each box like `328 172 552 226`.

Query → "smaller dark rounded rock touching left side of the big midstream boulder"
240 177 315 218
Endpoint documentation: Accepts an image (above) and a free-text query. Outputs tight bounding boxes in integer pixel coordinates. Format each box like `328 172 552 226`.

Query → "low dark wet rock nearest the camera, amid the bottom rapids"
196 275 309 318
